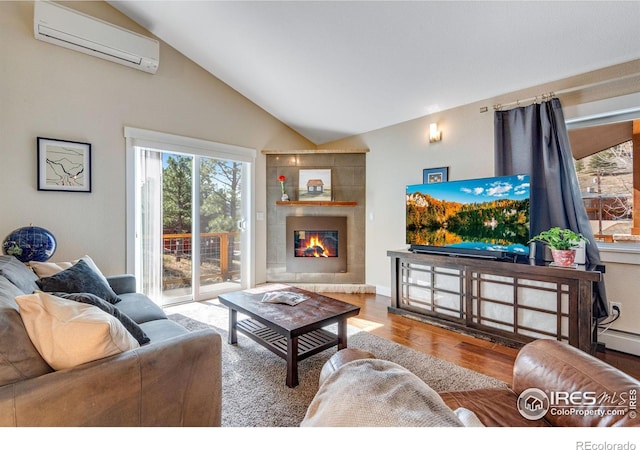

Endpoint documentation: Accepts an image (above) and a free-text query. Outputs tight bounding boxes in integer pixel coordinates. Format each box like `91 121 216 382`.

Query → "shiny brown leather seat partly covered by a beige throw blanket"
312 339 640 427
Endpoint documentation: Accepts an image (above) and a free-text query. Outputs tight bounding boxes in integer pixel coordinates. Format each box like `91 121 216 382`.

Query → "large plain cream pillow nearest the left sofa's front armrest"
16 292 140 370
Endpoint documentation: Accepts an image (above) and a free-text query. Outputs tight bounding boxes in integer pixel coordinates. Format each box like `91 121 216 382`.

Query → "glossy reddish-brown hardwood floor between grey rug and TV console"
326 293 640 384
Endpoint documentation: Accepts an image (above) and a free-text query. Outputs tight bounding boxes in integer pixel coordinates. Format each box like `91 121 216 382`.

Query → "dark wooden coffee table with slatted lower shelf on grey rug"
218 284 360 387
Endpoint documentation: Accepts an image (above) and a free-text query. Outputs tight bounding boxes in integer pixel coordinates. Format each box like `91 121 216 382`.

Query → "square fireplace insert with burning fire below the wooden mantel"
286 216 347 273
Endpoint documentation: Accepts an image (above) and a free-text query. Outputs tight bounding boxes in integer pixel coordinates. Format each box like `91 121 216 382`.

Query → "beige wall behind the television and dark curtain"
320 61 640 354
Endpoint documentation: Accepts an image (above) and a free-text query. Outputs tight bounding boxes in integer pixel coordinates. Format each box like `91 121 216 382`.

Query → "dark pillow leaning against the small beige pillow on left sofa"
36 259 120 305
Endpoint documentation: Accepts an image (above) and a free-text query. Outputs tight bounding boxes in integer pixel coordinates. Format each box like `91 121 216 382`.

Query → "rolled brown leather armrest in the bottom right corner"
512 339 640 427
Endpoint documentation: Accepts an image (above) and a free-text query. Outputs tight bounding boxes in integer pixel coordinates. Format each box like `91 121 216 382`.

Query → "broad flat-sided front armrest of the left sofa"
0 329 222 427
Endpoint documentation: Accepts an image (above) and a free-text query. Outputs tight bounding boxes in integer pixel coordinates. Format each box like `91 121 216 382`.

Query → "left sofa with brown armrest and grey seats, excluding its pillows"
0 256 222 427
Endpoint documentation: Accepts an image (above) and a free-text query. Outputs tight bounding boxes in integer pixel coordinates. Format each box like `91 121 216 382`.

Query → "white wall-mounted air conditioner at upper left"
33 1 160 73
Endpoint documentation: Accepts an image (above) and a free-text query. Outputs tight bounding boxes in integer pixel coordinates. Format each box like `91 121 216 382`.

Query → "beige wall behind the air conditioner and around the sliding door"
0 2 313 281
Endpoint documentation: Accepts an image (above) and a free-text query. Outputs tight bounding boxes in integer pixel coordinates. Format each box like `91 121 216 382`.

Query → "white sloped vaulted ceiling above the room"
109 1 640 144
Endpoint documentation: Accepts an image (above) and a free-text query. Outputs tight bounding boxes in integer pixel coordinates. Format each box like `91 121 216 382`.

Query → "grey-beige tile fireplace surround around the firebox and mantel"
263 150 375 292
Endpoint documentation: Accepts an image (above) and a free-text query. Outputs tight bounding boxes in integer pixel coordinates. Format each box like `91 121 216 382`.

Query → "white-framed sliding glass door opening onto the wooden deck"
125 128 252 305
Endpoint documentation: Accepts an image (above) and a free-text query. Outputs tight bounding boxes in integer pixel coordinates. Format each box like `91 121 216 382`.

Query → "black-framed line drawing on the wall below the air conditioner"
38 137 91 192
